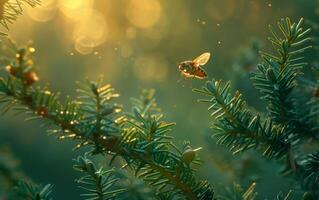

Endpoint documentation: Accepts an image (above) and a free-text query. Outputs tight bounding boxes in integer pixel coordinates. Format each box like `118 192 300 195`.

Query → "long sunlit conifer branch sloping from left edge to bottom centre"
0 39 213 200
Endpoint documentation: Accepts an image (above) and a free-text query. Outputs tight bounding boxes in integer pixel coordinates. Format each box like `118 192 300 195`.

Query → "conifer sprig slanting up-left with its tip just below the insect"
194 80 289 159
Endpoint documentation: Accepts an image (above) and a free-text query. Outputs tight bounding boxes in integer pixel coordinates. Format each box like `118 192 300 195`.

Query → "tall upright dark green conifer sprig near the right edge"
252 18 316 172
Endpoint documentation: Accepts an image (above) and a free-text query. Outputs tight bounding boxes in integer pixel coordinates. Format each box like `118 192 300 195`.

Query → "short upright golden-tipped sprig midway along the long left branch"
75 78 125 153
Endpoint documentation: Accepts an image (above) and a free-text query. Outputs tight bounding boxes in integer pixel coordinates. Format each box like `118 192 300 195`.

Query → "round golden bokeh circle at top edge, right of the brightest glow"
126 0 162 28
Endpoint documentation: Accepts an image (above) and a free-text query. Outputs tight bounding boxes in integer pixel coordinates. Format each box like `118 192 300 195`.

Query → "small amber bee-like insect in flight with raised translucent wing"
178 53 210 79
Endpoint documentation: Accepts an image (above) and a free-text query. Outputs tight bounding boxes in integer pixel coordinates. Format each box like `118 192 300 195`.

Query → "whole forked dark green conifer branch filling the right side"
195 18 318 199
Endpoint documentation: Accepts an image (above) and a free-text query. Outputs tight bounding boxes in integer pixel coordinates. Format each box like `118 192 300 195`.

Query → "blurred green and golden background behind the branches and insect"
0 0 319 199
